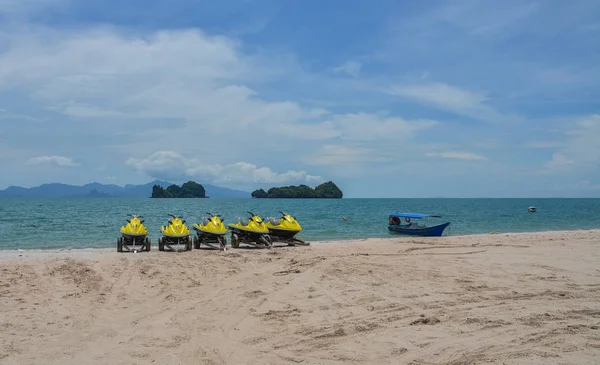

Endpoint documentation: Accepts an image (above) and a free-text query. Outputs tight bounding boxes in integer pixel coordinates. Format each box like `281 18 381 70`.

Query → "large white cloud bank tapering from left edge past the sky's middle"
0 28 436 161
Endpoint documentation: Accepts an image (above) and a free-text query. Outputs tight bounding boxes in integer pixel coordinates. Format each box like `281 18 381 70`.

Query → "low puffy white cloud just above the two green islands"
125 151 323 185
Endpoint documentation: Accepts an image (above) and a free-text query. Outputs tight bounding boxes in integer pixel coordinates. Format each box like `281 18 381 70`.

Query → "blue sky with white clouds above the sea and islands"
0 0 600 198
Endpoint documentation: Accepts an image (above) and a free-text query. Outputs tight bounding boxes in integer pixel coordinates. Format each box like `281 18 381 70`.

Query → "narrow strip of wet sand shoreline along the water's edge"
0 228 600 260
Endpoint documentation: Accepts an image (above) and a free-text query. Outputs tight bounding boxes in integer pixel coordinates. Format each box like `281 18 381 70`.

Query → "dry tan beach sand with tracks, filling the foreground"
0 230 600 365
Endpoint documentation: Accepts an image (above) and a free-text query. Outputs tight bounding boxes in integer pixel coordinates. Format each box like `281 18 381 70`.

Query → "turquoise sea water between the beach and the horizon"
0 199 600 250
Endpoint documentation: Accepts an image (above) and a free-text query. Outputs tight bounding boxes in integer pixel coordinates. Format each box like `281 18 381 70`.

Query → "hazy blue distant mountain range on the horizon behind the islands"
0 180 251 199
